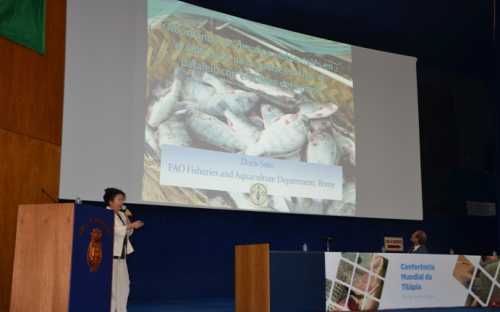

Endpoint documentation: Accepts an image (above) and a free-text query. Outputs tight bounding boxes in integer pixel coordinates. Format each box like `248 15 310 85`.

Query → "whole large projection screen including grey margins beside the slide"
60 0 422 219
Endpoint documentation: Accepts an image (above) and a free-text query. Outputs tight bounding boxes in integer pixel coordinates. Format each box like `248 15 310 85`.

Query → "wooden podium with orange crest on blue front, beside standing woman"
10 204 114 312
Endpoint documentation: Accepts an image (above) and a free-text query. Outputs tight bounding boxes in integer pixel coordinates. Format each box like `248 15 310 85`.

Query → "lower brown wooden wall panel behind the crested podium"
0 129 61 309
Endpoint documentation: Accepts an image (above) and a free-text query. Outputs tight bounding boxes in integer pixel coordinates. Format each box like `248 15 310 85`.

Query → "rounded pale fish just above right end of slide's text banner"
307 130 338 165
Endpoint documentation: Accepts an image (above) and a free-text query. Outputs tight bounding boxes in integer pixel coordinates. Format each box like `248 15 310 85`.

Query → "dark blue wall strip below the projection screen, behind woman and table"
120 205 496 301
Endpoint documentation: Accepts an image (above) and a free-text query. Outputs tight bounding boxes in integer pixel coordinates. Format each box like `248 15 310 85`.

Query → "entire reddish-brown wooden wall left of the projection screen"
0 0 66 311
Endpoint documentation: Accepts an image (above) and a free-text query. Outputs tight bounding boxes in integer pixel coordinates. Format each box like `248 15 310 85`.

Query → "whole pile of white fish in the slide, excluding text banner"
145 68 356 215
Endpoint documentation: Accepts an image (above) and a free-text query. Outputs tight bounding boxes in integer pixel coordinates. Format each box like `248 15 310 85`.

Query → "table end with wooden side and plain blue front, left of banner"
235 244 325 312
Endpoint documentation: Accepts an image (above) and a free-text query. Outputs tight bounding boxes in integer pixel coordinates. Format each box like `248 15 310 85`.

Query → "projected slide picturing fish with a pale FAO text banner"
142 0 356 215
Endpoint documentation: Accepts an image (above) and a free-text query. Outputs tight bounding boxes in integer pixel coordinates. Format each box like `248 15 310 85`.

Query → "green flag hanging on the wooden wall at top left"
0 0 45 54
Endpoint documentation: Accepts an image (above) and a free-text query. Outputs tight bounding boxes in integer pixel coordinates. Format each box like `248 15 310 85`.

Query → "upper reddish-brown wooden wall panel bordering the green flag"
0 0 66 145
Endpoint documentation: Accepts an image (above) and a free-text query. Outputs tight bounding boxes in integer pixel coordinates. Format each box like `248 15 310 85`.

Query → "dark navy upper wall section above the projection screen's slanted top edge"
185 0 495 77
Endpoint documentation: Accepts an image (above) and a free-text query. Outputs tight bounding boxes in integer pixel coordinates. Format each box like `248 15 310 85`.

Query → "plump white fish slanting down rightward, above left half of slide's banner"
185 109 246 152
